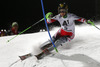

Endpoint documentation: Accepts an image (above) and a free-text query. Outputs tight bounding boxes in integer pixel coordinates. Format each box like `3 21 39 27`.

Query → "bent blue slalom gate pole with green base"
41 0 58 52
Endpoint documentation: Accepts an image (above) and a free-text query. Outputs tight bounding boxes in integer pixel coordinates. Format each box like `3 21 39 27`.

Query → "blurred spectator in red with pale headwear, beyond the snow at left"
7 22 19 35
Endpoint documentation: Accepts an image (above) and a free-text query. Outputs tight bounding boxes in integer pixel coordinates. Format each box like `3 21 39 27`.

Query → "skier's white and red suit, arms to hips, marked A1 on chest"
47 13 86 41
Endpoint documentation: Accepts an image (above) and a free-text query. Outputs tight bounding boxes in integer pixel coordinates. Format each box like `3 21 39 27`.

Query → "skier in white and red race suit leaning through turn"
20 3 94 60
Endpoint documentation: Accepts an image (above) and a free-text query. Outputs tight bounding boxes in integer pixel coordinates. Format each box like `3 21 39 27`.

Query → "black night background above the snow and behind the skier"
0 0 100 32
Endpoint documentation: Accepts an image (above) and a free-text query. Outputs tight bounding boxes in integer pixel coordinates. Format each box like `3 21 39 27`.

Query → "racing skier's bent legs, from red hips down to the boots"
36 29 72 59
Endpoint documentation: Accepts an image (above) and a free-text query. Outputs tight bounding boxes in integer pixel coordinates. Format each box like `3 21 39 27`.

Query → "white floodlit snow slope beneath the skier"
0 24 100 67
